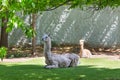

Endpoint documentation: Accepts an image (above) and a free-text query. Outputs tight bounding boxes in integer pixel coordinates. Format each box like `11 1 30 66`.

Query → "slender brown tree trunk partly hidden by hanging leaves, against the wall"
31 14 36 55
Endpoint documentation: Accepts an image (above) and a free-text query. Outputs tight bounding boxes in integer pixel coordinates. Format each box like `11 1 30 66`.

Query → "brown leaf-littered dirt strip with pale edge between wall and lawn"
0 45 120 62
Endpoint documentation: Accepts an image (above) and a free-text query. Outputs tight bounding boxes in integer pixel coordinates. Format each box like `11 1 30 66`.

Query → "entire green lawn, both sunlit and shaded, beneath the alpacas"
0 58 120 80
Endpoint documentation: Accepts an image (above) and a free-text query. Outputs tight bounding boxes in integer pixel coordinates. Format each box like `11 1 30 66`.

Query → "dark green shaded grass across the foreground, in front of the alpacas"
0 65 120 80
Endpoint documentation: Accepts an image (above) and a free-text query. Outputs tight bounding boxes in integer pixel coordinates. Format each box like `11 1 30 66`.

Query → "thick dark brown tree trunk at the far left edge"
0 17 8 48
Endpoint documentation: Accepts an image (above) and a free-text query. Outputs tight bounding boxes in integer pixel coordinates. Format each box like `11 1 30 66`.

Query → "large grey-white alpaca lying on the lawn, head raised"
42 34 79 69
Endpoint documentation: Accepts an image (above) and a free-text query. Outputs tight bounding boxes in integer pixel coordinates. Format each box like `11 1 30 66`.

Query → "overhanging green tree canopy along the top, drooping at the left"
0 0 120 37
